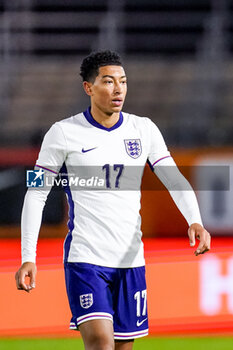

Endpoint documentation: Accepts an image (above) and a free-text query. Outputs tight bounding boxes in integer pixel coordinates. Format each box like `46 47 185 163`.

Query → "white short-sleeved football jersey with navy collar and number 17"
33 109 170 268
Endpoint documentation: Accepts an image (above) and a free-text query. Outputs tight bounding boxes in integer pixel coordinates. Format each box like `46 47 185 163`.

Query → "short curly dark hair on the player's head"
80 50 122 82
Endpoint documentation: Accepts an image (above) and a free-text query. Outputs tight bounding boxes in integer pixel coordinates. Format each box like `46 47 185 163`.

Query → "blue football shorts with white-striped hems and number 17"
64 263 148 340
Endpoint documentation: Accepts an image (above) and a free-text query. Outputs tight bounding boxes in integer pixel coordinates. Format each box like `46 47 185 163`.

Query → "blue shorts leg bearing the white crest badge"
65 263 113 330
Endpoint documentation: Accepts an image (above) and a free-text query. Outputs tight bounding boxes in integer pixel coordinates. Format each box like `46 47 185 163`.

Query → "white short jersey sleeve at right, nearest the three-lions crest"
148 120 170 167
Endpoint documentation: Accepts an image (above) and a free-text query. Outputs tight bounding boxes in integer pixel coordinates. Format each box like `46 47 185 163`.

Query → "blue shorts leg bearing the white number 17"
113 266 148 340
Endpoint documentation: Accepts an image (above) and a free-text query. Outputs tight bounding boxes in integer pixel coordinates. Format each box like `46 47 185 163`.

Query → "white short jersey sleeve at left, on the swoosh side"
36 123 67 172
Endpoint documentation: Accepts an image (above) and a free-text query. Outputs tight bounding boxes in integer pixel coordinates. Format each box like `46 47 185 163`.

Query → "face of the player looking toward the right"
84 66 127 115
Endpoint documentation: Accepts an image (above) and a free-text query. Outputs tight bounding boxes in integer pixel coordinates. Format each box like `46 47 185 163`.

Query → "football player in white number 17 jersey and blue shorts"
16 51 210 350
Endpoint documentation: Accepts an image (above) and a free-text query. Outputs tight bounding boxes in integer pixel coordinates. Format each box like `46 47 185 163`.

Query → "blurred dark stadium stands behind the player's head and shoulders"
0 0 233 232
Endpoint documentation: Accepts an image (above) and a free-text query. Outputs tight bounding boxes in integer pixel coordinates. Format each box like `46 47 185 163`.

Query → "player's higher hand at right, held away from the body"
188 224 211 256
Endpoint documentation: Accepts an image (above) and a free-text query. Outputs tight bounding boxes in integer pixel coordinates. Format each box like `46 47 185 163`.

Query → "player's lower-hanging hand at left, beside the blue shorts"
15 262 37 293
